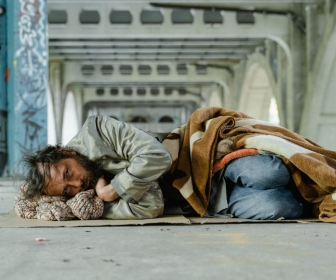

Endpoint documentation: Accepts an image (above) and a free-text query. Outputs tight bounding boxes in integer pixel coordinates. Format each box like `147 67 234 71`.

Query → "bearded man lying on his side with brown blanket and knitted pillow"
15 107 336 222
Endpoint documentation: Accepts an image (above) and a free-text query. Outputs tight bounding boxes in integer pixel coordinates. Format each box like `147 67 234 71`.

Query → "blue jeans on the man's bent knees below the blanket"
224 155 303 220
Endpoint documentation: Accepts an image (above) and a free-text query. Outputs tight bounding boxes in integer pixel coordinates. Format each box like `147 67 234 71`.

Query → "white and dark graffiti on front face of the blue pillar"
15 0 48 153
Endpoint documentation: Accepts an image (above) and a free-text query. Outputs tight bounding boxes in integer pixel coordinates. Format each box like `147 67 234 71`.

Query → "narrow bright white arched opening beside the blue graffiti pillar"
62 91 79 145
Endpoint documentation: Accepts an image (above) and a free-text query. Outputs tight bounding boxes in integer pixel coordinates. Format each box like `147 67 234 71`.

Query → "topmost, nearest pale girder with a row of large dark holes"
48 1 289 39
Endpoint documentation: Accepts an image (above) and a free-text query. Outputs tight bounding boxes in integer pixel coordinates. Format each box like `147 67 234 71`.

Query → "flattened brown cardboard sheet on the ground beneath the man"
0 210 320 228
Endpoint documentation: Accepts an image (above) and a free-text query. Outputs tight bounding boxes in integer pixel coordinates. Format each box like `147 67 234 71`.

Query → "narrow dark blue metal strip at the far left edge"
0 0 7 176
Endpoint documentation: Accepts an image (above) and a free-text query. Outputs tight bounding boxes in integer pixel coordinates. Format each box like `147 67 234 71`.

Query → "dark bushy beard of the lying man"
71 153 103 191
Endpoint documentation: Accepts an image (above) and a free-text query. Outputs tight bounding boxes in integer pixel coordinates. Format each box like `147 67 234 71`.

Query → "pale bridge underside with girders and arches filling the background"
0 0 336 175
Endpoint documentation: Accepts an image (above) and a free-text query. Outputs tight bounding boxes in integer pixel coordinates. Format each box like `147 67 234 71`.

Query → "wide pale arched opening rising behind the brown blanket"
238 63 280 124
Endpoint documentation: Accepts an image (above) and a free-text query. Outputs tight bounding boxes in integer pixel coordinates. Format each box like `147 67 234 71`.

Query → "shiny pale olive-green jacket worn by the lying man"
67 116 172 219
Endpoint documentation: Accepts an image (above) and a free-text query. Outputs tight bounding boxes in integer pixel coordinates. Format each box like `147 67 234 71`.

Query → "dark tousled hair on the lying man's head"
21 145 69 199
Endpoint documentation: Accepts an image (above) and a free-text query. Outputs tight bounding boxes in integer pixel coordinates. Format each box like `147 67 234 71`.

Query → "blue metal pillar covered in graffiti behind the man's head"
6 0 48 175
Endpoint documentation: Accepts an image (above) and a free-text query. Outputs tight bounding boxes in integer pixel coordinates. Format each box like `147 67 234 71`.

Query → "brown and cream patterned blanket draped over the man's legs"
163 107 336 222
